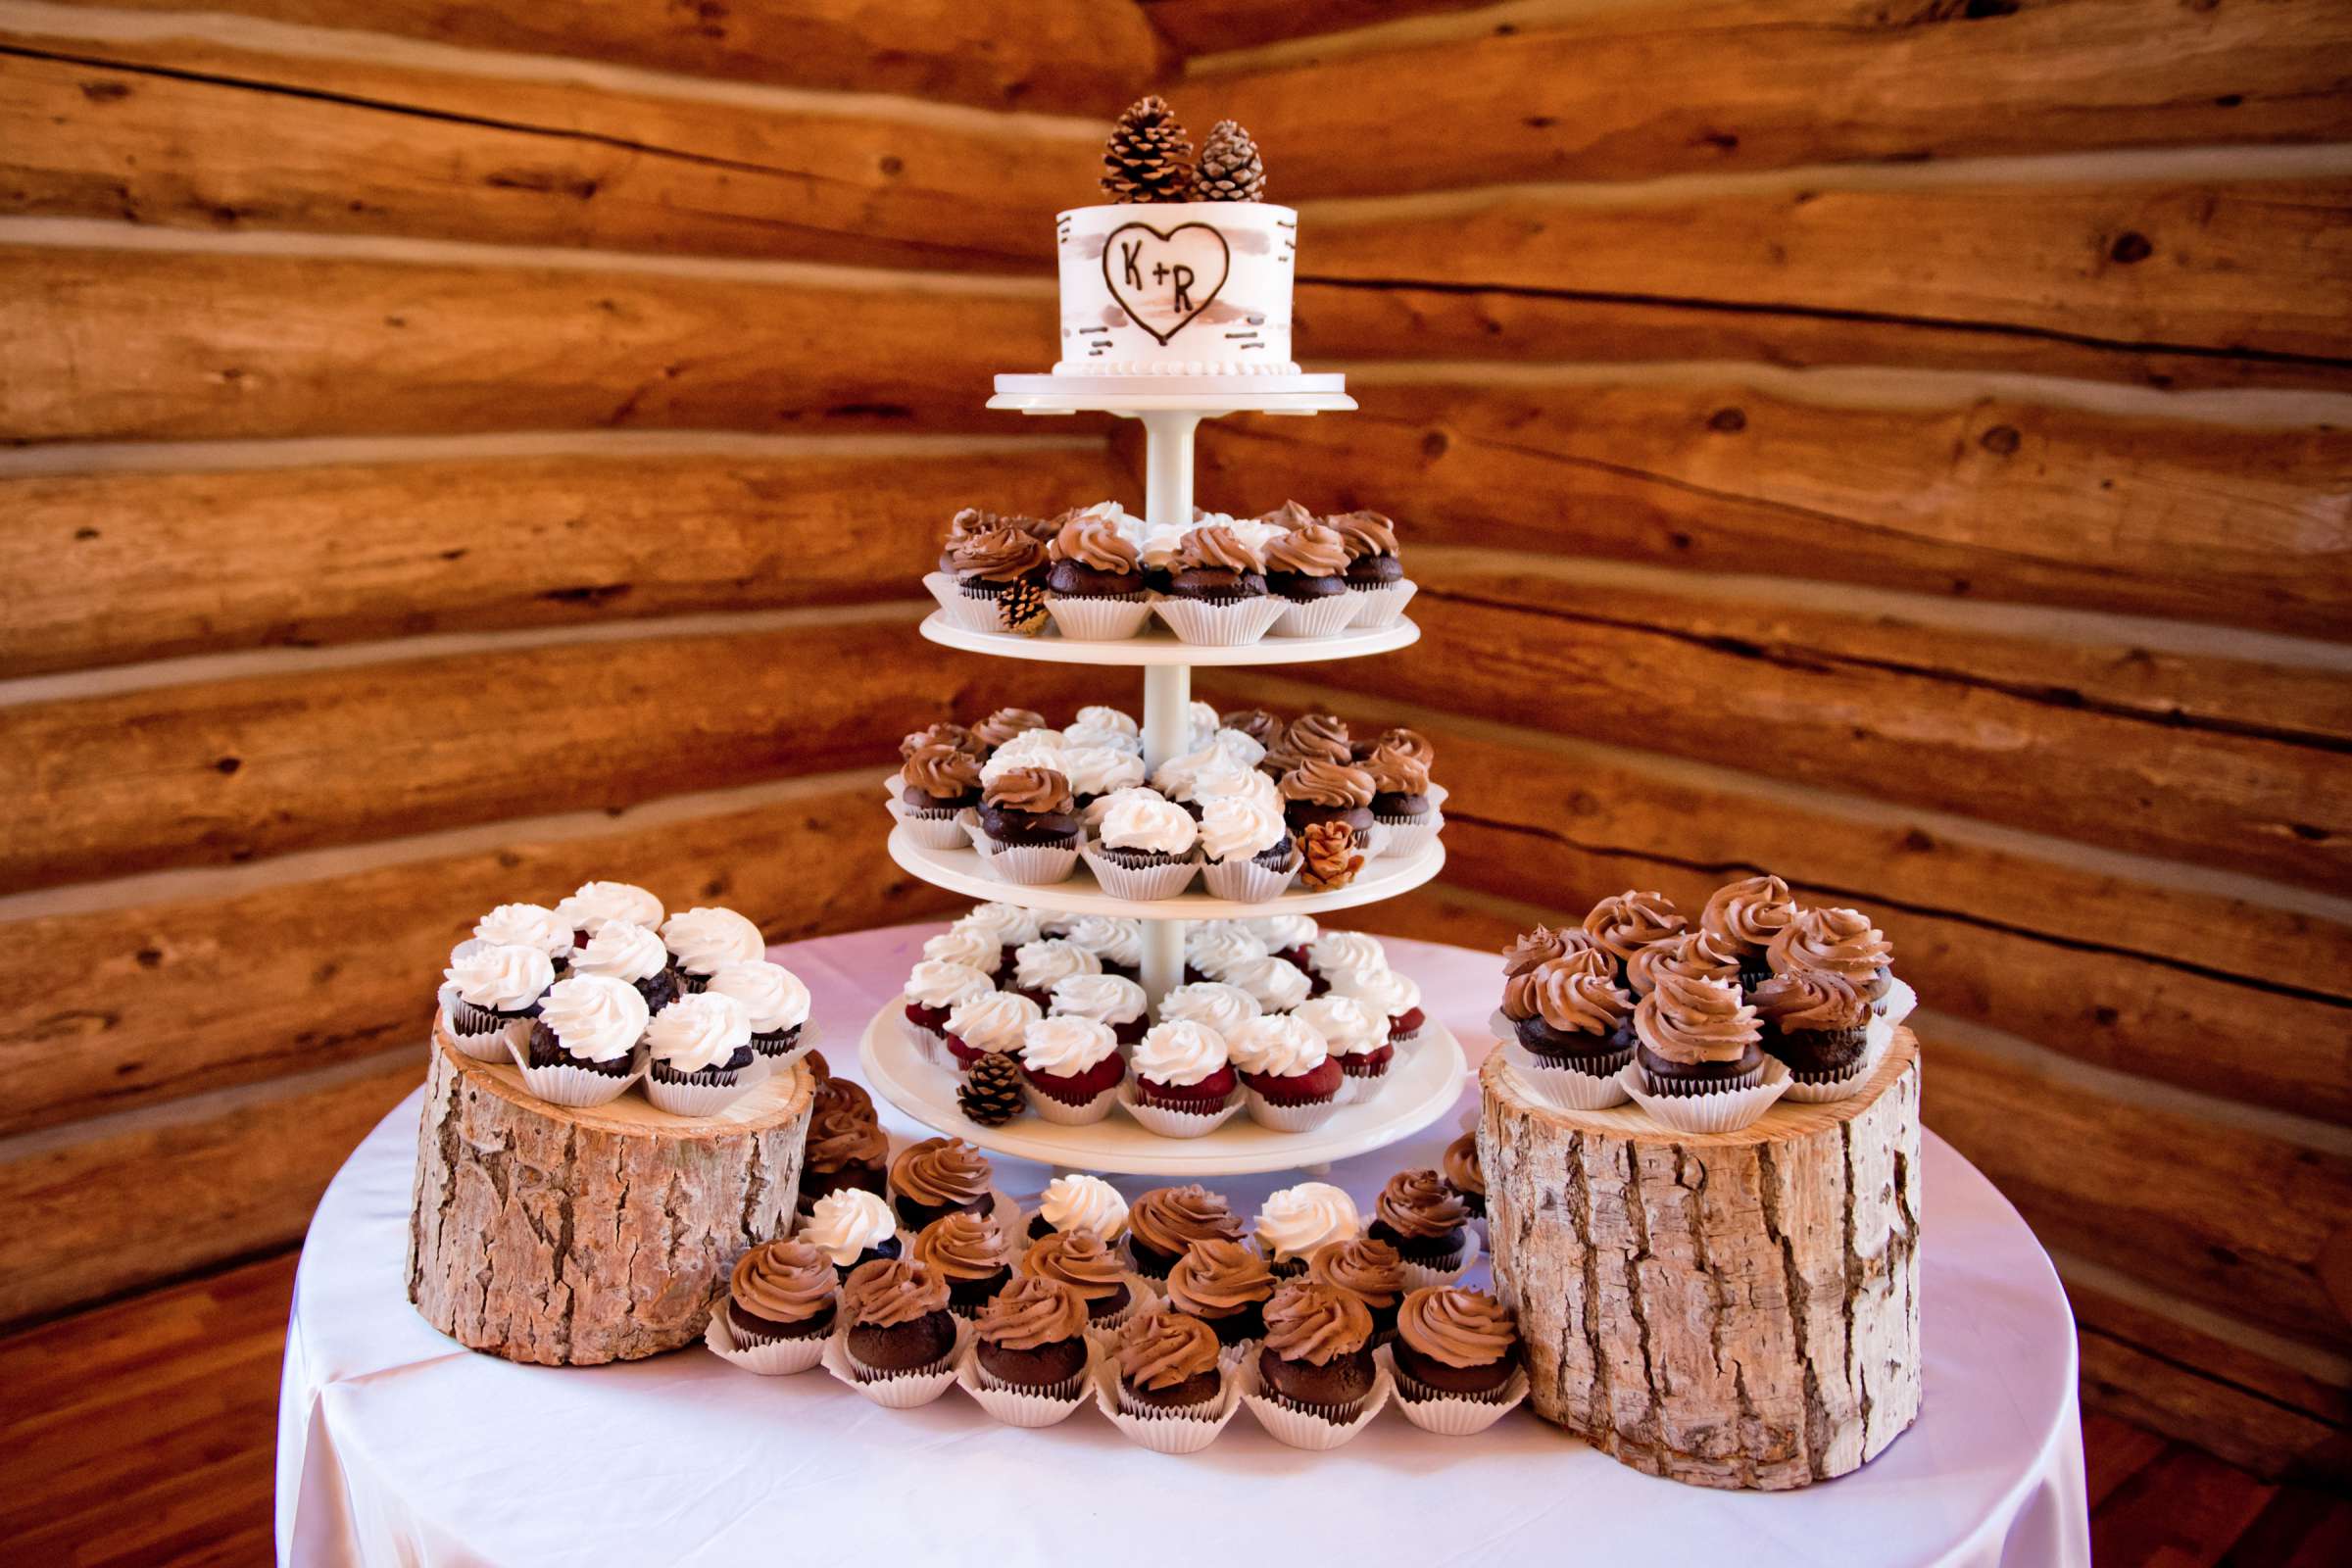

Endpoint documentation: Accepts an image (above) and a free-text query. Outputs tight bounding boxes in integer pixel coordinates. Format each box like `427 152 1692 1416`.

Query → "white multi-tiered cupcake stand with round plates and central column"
858 376 1468 1178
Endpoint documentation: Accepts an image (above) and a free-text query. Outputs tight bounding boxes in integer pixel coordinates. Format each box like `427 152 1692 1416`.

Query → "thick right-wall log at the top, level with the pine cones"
1171 0 2352 195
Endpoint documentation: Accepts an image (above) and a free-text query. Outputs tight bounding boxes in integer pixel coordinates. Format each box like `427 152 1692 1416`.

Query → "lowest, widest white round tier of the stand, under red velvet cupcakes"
858 1002 1470 1178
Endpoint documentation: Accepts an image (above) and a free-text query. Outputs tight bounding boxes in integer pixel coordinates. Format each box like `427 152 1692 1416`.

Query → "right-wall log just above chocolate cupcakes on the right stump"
1195 684 2352 1121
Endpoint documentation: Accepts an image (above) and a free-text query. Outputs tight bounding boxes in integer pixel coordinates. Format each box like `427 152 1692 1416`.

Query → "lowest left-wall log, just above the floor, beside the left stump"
0 1046 425 1324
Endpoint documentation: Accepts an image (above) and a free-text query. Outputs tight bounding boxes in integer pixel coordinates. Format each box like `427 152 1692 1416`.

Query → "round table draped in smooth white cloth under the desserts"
277 926 2091 1568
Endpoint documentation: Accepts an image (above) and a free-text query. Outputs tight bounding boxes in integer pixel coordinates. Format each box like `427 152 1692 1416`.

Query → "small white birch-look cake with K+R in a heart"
1054 202 1298 376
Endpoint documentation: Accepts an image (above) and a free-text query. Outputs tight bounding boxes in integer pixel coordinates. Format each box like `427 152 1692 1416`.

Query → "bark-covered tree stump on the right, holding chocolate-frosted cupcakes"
1480 1030 1919 1491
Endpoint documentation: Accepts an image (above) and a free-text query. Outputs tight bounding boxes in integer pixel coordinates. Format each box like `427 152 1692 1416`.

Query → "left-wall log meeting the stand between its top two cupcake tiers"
0 615 1103 889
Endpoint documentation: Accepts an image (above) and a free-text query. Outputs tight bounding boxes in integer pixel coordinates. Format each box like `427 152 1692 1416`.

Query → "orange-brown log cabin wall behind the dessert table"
0 0 2352 1472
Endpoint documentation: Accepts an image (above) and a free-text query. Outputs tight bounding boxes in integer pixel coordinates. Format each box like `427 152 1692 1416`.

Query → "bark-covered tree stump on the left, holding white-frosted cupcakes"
407 1032 813 1366
